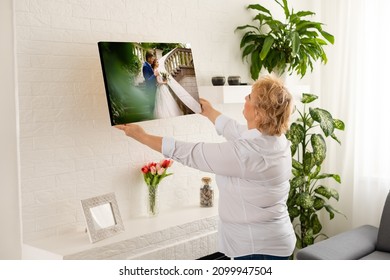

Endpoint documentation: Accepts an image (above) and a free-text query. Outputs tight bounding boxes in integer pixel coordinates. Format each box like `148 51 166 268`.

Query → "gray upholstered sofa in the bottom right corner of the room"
296 193 390 260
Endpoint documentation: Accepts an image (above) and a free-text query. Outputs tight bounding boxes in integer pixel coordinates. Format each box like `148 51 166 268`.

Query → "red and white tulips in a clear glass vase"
141 159 173 216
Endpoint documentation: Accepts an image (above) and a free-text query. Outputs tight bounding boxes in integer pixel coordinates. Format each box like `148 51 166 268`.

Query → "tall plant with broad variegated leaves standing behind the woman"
286 94 345 248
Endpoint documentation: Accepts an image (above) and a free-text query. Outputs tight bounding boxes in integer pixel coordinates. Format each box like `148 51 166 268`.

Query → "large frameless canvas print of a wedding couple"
98 42 200 125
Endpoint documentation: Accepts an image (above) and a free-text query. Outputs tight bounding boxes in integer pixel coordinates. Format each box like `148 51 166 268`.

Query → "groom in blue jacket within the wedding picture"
142 50 157 114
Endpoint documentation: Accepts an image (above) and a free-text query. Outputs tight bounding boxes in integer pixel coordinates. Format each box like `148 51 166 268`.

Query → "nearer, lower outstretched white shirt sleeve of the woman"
162 137 245 177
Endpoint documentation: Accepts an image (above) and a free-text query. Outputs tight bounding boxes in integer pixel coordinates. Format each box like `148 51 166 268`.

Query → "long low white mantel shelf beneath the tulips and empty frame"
23 205 218 260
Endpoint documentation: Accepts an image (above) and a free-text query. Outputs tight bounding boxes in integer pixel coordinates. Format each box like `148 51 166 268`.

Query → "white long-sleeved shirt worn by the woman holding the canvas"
162 115 296 257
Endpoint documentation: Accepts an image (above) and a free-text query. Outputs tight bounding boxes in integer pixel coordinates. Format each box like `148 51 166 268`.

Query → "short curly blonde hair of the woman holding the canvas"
251 75 293 136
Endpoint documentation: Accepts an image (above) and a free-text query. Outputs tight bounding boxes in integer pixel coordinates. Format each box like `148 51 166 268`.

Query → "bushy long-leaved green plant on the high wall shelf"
236 0 334 80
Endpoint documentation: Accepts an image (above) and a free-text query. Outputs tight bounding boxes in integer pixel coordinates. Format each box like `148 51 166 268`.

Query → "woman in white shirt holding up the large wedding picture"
117 76 296 259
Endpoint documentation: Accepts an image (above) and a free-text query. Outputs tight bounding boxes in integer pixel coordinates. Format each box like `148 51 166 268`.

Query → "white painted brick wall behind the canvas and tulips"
14 0 251 240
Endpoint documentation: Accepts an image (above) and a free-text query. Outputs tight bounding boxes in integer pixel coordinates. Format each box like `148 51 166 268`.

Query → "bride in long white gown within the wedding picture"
152 59 183 119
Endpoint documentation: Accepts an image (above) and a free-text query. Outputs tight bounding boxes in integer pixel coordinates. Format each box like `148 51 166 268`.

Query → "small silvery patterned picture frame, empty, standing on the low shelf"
81 192 125 243
